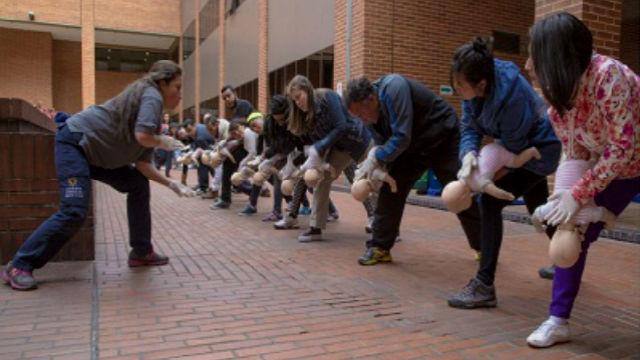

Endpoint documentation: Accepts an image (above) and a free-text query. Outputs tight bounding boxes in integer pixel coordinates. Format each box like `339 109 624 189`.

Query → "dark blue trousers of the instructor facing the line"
13 125 153 271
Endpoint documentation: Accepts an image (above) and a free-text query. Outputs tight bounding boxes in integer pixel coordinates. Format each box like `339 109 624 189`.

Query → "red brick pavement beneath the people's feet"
0 174 640 359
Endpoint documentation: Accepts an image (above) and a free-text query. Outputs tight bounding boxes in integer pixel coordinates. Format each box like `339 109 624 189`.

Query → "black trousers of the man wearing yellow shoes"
367 129 480 250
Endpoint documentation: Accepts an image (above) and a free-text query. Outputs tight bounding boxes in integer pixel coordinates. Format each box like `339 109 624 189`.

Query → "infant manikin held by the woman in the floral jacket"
531 160 616 268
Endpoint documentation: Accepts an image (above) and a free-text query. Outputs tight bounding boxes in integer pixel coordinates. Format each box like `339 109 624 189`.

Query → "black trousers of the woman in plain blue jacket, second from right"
476 168 555 285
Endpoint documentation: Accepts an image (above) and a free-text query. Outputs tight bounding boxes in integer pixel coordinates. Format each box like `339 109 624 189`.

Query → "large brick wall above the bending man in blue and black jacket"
334 0 535 110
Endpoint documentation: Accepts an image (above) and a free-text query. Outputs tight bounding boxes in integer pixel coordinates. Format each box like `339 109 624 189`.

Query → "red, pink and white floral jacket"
548 54 640 205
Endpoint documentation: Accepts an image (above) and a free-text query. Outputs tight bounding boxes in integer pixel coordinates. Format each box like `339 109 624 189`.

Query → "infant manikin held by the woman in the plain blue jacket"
442 142 541 214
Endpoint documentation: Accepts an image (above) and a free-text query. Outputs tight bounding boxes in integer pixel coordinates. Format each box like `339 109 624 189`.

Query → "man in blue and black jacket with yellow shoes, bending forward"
344 74 480 265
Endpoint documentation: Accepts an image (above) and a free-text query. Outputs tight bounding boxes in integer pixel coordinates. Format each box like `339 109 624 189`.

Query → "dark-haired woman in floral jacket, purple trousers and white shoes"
527 13 640 347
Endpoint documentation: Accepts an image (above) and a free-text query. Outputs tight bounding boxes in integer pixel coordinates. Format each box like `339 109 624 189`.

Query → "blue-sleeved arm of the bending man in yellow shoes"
376 75 413 164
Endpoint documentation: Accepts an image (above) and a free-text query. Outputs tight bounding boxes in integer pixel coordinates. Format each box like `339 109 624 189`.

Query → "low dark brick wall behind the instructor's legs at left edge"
0 99 94 264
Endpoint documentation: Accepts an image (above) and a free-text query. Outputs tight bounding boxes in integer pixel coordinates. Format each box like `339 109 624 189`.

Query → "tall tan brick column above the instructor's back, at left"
80 0 96 108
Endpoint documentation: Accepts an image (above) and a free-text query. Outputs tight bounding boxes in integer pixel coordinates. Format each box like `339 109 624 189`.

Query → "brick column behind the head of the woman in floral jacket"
536 0 622 58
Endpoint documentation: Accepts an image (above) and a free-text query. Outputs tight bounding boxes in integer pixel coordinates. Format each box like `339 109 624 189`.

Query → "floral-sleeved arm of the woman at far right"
571 63 640 205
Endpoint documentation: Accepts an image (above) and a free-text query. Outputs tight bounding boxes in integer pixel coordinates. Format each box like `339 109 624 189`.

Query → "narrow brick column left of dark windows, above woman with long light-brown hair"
258 0 269 114
